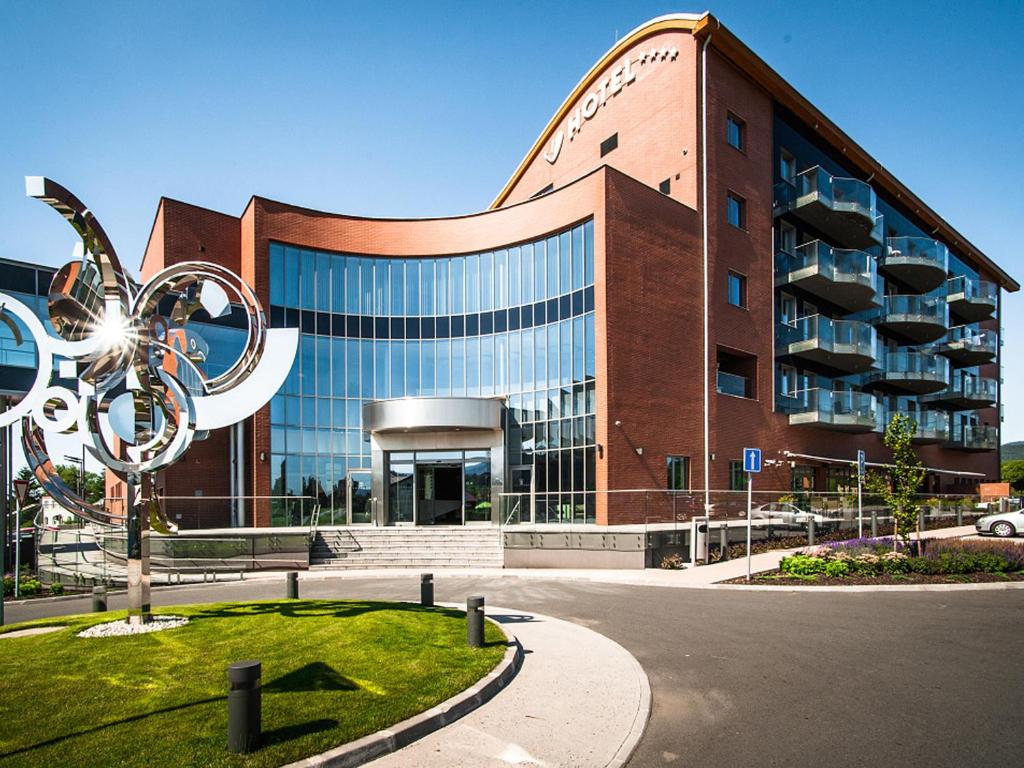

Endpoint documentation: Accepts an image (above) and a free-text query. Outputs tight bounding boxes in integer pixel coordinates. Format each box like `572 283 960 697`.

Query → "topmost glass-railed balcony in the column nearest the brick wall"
773 166 883 248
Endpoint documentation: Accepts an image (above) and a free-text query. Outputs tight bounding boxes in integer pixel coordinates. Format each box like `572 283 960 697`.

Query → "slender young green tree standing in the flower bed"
865 414 926 548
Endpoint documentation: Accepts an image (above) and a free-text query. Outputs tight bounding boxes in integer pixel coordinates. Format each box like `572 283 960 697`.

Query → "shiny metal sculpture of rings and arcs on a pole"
0 176 298 623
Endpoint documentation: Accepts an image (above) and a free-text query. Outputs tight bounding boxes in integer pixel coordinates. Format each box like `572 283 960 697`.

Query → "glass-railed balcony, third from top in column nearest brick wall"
775 314 878 375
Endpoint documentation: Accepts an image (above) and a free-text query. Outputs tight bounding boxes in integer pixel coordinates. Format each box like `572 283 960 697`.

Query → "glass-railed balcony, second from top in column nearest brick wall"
775 240 881 312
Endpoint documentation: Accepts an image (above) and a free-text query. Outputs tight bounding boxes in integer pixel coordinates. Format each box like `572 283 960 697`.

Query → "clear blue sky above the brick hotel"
6 0 1024 440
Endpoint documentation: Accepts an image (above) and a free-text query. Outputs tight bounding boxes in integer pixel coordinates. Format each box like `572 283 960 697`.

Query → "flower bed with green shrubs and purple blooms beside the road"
758 538 1024 584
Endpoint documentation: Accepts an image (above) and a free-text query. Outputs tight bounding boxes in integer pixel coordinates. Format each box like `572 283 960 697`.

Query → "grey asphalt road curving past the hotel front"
7 573 1024 768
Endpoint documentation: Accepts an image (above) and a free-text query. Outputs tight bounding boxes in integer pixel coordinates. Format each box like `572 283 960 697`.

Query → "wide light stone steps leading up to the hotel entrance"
309 525 504 569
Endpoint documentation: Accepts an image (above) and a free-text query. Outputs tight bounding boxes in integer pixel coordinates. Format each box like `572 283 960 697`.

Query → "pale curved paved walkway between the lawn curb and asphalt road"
368 606 650 768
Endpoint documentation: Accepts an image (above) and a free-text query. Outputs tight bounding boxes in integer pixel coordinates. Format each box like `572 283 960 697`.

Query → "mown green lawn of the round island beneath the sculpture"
0 600 505 768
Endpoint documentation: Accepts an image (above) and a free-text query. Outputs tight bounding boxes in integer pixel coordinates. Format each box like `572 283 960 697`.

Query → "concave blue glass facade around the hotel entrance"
269 220 596 524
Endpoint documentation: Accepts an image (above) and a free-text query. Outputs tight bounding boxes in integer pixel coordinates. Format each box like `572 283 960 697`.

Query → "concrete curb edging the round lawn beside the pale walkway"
282 617 523 768
